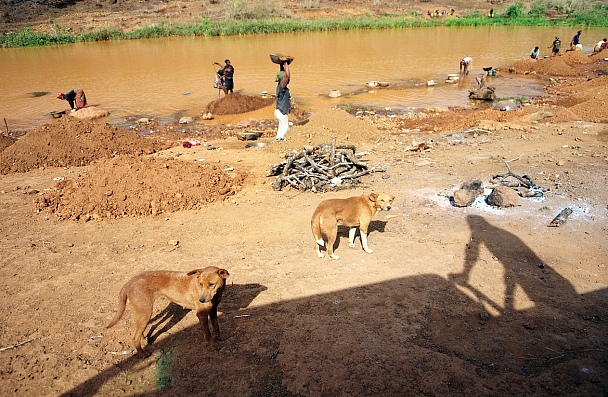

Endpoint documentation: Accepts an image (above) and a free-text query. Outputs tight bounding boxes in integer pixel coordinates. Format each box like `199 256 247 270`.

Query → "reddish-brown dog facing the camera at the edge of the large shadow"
107 266 229 357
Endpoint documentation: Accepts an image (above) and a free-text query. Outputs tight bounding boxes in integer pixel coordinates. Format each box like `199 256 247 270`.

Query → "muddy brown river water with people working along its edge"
0 27 605 129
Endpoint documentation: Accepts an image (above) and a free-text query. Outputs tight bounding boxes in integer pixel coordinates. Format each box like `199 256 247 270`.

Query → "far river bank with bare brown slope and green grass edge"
0 0 608 48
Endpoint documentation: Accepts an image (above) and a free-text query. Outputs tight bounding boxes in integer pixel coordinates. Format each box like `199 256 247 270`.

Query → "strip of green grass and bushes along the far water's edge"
0 0 608 48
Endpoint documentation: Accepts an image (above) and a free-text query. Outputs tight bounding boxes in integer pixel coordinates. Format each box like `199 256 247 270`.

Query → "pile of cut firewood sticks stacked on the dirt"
267 141 386 192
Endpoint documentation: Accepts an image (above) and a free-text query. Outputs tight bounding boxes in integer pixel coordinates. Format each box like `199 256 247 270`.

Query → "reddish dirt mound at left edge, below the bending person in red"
0 117 170 175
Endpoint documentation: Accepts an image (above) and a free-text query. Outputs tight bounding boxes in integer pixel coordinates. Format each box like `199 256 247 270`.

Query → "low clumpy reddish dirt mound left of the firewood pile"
35 155 246 221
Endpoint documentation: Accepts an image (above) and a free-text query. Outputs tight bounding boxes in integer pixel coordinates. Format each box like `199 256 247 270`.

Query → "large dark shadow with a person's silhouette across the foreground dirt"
64 217 608 396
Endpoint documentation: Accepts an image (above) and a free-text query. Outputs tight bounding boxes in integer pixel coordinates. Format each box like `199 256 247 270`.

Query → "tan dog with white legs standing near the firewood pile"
310 193 395 259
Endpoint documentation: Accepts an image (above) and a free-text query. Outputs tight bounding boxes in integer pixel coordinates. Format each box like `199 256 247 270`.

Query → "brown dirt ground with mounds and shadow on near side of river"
0 40 608 396
